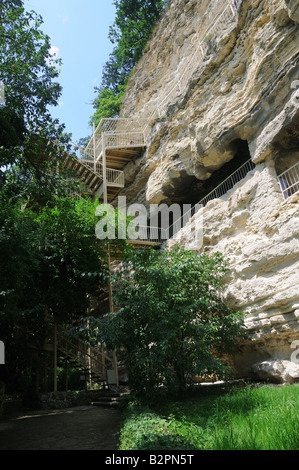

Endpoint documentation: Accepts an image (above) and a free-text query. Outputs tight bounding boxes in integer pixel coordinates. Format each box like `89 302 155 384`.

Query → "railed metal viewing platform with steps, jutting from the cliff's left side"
64 118 151 203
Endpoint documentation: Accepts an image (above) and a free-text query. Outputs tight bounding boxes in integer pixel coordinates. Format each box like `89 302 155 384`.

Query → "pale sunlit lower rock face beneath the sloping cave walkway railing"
169 163 299 379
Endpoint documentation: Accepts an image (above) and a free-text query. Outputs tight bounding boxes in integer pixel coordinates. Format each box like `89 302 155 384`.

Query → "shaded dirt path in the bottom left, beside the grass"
0 406 120 450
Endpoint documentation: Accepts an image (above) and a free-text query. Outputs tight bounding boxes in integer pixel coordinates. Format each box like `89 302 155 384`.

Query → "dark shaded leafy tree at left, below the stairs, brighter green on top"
0 192 117 391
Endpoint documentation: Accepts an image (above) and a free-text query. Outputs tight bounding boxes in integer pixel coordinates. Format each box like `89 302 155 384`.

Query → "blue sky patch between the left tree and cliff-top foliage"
24 0 115 142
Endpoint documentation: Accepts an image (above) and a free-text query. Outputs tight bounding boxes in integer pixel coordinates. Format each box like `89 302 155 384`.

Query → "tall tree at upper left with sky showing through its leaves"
0 0 69 184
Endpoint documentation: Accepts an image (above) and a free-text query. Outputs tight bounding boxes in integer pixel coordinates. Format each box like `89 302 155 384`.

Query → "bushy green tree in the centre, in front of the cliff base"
100 247 244 399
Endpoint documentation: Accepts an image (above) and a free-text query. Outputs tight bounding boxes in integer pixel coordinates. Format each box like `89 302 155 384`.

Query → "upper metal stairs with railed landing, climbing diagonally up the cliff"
64 0 241 203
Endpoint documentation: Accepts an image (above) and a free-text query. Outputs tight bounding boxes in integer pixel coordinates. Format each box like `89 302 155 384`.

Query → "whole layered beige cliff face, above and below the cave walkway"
118 0 299 381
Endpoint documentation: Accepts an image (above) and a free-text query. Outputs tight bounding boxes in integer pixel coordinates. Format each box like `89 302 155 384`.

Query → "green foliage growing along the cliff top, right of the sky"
91 0 167 124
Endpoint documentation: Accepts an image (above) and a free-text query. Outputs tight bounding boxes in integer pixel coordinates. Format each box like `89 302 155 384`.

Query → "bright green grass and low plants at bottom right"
120 385 299 450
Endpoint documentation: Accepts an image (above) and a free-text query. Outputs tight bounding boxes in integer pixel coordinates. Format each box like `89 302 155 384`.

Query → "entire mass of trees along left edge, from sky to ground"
0 0 116 391
